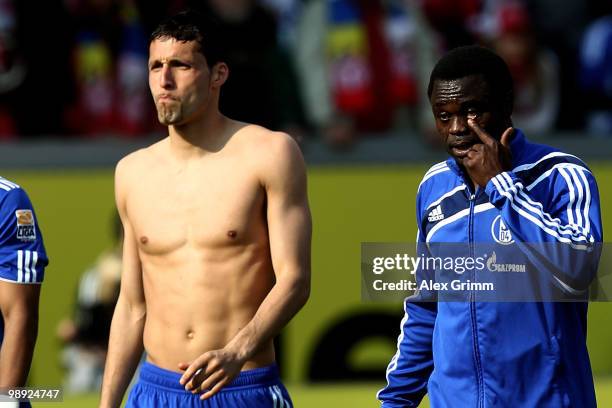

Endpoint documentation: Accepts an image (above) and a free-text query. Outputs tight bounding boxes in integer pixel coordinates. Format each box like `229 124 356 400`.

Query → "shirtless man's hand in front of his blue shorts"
179 349 246 400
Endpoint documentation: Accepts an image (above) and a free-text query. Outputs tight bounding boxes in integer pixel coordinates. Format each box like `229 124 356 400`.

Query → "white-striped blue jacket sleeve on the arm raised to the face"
486 165 603 295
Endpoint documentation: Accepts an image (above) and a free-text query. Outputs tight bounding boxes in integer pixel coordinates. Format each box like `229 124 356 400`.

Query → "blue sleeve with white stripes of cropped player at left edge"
0 188 48 284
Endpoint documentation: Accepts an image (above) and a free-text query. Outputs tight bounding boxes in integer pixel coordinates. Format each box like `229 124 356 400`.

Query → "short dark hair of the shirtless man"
149 10 225 68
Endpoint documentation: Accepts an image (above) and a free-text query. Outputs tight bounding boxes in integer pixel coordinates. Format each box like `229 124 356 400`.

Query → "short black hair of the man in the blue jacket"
427 45 514 110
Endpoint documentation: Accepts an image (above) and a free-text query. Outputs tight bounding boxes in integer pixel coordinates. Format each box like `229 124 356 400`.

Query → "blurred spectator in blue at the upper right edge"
580 15 612 135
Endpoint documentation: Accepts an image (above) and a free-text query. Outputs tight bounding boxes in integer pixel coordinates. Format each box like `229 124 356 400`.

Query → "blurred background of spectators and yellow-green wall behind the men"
0 0 612 407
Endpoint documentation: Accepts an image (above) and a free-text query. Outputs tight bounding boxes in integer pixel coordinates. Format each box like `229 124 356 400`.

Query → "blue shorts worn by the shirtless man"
126 361 293 408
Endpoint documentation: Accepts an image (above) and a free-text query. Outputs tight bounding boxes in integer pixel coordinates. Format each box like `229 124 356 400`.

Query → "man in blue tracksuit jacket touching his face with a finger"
378 46 603 408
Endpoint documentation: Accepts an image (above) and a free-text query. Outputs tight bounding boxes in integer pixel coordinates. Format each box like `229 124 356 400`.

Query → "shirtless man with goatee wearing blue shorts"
100 12 311 407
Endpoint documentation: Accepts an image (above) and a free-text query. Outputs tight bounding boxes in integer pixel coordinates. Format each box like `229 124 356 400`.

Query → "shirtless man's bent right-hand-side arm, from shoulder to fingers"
181 134 312 399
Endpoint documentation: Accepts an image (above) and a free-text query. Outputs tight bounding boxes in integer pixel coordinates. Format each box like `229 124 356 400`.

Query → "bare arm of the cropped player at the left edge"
0 281 40 388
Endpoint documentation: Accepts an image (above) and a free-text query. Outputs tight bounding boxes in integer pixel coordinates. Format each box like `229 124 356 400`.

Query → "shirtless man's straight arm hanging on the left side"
100 159 146 407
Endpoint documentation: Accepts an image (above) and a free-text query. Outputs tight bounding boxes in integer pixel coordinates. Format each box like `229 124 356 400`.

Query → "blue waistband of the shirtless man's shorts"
139 361 280 391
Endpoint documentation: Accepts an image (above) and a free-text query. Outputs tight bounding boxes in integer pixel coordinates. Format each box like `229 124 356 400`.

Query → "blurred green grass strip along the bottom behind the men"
33 377 612 408
